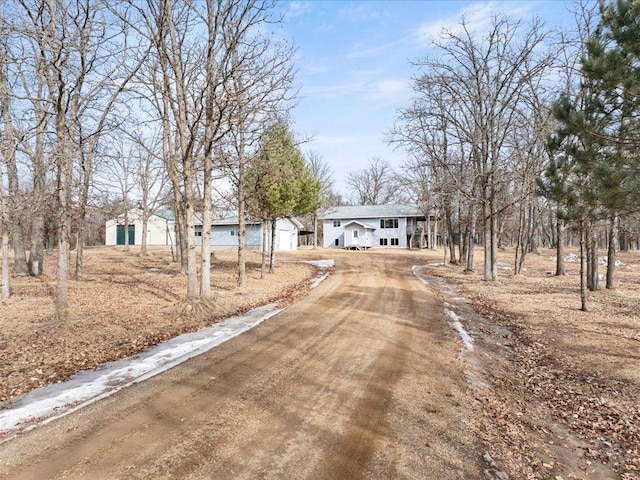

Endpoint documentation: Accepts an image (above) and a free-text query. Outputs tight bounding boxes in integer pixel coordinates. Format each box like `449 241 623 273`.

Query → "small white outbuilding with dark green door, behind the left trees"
105 208 175 245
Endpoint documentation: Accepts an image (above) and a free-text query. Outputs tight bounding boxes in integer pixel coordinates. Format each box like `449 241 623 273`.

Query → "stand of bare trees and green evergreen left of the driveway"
0 0 320 313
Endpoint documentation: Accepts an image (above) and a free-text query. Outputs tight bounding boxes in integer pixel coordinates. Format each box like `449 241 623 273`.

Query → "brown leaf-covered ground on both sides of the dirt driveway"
0 248 640 480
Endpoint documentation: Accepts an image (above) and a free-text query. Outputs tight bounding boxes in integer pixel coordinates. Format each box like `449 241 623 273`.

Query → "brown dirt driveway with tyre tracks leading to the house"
0 252 484 479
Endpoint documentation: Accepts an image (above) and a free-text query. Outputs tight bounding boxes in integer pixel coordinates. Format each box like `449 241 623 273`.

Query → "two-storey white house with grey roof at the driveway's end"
320 205 426 249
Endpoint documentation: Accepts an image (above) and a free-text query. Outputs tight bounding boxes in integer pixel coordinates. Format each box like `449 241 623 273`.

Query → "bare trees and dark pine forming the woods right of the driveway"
389 0 640 309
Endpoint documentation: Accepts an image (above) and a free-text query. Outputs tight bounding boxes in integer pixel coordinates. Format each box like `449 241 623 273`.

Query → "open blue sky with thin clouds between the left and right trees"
272 0 584 196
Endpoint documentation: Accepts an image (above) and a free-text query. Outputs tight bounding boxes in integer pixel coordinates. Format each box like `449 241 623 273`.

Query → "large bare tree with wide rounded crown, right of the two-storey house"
392 16 552 280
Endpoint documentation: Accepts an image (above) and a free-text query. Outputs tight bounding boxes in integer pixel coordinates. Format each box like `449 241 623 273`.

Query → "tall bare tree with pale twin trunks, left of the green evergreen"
127 0 292 300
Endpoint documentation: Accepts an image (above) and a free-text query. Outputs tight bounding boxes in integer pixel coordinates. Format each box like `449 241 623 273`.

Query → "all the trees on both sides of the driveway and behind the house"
0 0 640 312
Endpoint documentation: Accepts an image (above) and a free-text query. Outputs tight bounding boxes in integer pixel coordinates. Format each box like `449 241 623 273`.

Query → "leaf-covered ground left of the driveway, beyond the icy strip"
0 247 315 408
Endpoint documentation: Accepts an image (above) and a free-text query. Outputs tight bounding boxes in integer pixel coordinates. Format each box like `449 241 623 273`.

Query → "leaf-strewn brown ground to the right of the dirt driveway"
428 249 640 480
